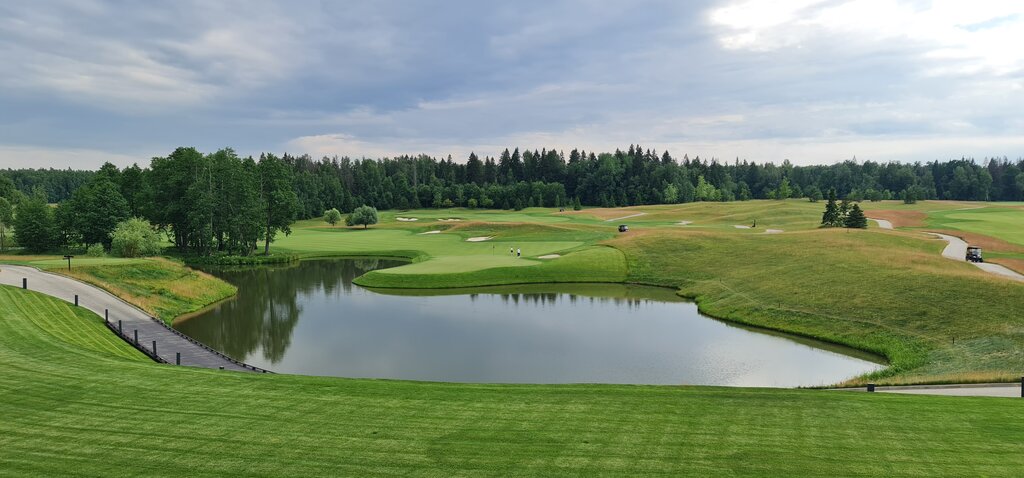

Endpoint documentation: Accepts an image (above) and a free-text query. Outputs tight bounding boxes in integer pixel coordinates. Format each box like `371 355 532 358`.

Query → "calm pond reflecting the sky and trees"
175 259 883 387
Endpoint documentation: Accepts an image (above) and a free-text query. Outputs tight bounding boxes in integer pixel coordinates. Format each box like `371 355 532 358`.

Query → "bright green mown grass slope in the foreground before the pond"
0 287 1024 476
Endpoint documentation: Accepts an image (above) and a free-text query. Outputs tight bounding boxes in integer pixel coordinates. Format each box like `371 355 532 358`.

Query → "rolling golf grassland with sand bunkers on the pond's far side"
268 201 1024 384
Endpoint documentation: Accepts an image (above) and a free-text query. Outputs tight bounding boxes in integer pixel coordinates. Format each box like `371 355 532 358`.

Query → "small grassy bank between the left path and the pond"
0 256 238 323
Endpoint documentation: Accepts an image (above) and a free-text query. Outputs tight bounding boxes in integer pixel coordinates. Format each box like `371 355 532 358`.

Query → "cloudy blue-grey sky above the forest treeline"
0 0 1024 169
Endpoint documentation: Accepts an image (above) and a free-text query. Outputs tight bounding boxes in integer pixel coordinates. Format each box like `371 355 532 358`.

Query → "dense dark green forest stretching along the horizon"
0 145 1024 255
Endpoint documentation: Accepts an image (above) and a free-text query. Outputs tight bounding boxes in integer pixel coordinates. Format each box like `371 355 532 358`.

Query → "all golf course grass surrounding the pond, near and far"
0 200 1024 476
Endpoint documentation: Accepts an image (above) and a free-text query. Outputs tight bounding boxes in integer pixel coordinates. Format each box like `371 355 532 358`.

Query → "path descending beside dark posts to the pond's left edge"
0 265 263 372
